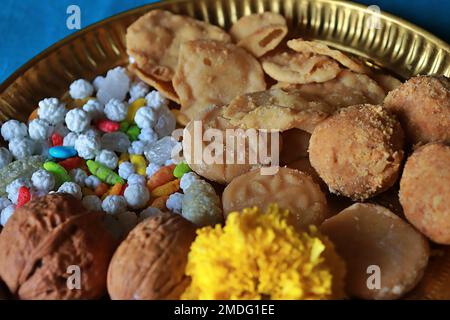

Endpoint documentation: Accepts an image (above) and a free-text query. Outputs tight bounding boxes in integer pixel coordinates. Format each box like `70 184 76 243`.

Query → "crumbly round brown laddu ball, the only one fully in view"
309 105 403 200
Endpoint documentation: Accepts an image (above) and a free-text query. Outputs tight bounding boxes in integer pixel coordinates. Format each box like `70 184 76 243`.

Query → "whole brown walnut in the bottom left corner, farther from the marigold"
0 194 116 300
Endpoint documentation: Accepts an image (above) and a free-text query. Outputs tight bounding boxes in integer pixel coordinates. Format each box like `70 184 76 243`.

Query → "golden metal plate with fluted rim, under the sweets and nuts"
0 0 450 299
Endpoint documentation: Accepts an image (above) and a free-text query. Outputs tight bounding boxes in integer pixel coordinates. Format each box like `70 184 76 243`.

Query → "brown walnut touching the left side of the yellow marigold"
108 213 196 300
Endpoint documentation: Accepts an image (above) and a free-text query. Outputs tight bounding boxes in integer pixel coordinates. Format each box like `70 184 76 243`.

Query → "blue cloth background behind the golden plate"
0 0 450 82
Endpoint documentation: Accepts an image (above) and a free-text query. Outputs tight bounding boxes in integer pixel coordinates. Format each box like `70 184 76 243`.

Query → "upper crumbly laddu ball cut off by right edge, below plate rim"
384 76 450 144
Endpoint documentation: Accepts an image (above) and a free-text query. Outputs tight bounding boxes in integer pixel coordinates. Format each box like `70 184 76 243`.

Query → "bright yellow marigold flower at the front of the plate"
182 205 345 299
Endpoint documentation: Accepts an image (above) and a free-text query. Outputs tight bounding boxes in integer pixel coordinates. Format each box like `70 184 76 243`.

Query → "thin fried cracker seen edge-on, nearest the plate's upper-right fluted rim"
287 39 370 74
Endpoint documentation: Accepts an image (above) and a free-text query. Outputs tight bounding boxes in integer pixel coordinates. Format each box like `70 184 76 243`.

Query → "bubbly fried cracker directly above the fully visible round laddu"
275 70 386 112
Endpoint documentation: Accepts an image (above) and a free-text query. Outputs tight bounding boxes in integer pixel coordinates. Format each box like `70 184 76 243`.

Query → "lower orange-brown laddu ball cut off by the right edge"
399 143 450 244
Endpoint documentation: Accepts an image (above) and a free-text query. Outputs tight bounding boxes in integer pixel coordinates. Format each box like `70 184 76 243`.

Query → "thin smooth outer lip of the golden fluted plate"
0 0 450 94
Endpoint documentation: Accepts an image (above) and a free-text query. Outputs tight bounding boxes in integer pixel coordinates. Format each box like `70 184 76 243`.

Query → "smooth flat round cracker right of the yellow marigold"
320 203 429 299
